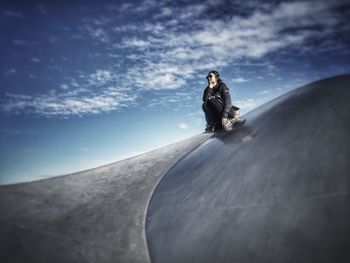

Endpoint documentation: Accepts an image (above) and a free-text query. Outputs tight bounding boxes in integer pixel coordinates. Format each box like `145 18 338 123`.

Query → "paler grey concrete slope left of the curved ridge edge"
0 134 210 263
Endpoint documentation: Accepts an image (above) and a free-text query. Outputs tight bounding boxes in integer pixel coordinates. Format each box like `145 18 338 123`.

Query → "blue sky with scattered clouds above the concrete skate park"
0 0 350 184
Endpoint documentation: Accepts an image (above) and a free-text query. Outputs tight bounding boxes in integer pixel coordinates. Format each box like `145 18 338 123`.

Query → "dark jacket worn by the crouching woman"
203 80 232 118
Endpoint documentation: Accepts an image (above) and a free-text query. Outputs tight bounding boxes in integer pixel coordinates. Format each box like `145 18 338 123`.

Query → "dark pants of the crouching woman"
202 98 239 125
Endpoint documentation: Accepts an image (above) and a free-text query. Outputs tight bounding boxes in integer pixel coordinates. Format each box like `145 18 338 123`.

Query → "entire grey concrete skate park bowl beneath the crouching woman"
0 75 350 262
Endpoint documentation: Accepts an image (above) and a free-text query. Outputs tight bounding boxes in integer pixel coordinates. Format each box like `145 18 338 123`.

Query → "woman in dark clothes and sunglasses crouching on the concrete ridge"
202 70 245 132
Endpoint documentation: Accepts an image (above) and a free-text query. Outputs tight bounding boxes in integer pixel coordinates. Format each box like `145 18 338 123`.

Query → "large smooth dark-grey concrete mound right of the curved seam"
146 75 350 263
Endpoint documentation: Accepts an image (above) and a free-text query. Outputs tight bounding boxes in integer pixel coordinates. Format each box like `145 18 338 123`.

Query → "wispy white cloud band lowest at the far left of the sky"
0 70 138 117
